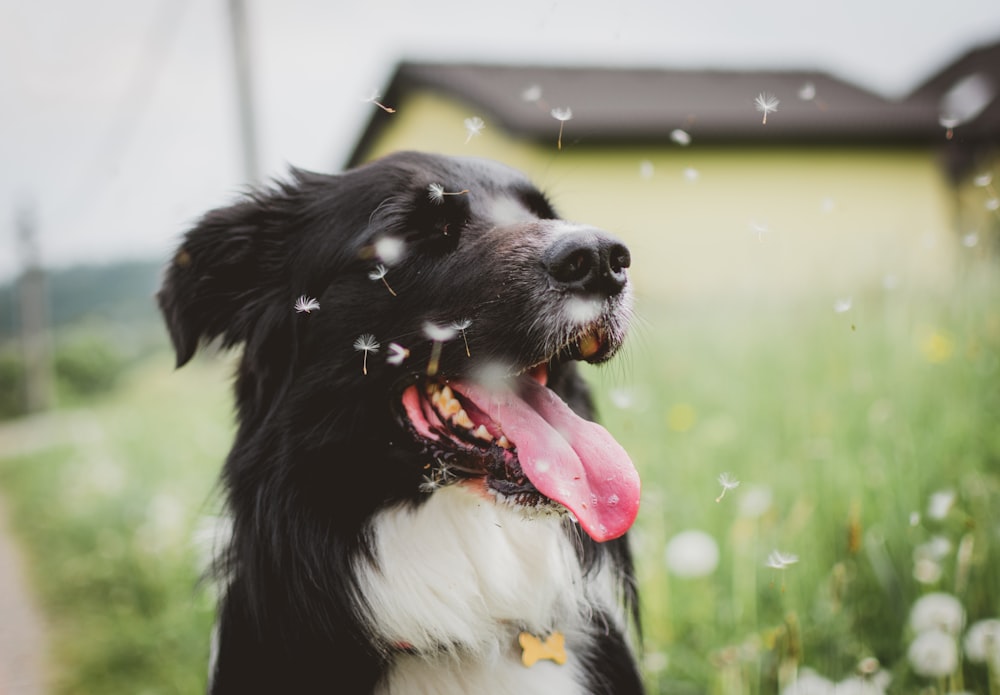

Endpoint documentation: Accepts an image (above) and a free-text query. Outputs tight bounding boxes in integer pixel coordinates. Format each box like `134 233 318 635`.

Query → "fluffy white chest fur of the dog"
356 485 616 694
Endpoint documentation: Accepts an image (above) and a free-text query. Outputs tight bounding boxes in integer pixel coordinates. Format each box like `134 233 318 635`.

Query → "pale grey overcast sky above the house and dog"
0 0 1000 281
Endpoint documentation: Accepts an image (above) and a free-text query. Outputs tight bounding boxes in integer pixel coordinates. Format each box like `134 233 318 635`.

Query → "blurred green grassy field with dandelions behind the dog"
0 264 1000 695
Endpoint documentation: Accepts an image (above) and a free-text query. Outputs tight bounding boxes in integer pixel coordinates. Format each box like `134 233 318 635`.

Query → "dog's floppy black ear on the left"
157 197 291 367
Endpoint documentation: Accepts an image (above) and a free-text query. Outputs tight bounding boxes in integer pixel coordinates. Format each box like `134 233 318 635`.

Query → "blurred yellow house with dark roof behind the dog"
348 43 1000 300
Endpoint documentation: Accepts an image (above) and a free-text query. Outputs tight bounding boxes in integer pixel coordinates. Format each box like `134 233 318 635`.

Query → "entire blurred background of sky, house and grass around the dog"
0 0 1000 695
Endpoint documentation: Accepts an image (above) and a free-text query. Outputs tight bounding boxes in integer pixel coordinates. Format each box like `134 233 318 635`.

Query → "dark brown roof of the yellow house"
351 43 1000 174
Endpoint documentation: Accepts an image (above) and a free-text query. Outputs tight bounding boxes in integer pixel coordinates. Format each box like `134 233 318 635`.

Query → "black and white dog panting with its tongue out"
158 153 642 695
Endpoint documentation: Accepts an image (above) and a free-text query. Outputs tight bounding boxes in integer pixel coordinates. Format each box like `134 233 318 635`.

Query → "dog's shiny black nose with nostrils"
542 228 632 297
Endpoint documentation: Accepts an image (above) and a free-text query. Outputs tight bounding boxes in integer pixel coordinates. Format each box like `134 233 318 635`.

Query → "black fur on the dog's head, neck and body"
158 153 641 695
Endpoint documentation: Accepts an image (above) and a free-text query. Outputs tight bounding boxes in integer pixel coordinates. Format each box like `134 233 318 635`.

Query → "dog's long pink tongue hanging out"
452 379 639 542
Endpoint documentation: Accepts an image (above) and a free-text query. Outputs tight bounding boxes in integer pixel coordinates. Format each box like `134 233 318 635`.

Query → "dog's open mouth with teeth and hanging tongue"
401 329 639 542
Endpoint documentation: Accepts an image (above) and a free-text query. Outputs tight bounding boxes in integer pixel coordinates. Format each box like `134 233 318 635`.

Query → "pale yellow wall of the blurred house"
364 94 958 298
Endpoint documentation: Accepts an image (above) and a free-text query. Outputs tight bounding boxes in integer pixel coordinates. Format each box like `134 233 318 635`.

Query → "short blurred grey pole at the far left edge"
15 206 53 413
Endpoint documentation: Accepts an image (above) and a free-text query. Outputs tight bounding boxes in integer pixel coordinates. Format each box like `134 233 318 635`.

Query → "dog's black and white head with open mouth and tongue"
159 153 639 541
